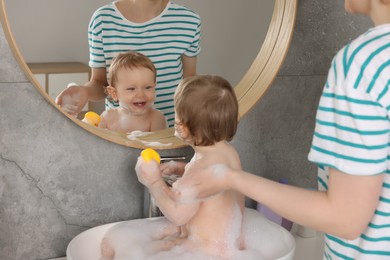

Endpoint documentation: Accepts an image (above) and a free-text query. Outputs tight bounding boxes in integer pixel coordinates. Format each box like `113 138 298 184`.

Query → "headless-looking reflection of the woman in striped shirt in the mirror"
56 0 201 126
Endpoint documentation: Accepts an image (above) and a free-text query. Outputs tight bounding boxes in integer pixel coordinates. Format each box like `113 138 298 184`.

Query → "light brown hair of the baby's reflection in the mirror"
108 51 156 87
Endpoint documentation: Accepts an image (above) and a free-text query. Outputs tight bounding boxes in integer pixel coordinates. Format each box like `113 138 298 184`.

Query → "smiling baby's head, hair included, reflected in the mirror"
107 51 156 114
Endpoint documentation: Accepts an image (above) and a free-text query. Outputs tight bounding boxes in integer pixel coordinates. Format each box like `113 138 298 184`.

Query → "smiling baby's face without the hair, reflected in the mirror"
115 67 156 115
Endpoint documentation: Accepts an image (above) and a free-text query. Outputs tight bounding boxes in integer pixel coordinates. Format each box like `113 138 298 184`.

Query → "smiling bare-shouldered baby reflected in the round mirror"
99 52 167 133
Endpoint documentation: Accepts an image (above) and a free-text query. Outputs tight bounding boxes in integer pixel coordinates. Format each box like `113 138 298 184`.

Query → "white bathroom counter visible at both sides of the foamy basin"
49 224 324 260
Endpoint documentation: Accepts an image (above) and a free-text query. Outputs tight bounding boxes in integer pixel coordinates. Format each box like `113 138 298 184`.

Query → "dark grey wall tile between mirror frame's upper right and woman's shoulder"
279 0 372 76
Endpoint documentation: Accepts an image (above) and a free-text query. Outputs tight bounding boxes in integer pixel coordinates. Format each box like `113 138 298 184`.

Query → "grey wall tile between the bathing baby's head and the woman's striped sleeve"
236 76 326 188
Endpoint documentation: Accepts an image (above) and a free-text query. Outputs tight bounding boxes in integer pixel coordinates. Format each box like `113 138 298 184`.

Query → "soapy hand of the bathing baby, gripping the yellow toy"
135 157 162 188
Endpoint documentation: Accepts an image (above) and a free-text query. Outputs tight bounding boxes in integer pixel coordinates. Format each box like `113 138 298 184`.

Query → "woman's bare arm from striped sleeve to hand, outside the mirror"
175 166 383 239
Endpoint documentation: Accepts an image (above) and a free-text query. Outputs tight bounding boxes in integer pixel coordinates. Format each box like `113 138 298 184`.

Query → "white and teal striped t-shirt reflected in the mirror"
88 2 201 126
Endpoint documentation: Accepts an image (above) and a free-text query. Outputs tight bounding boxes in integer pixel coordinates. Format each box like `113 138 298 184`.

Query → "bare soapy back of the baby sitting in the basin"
184 142 244 257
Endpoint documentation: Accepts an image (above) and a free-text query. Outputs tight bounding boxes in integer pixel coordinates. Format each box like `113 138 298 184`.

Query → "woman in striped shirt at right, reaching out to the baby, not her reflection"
167 0 390 260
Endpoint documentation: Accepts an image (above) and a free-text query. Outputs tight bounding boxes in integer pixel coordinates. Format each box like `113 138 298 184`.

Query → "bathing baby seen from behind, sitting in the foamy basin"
136 75 244 259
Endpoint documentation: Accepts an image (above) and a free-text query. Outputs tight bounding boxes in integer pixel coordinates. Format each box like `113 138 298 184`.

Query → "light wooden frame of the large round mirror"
0 0 298 149
